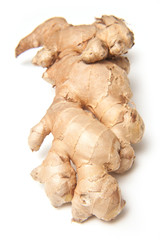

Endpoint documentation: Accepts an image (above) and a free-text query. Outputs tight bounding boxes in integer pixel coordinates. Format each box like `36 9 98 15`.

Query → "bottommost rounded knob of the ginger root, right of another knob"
72 166 125 222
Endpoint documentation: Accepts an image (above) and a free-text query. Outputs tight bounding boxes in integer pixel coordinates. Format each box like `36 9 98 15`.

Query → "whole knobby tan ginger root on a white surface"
16 15 144 222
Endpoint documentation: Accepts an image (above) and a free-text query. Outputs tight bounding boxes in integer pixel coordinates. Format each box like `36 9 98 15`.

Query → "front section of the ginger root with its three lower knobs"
29 98 125 222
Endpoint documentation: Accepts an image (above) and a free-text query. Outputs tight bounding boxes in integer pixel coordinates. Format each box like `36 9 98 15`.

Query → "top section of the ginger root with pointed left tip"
15 15 134 63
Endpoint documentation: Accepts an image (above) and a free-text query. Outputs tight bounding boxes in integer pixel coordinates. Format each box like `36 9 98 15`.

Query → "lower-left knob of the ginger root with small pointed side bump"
30 138 76 207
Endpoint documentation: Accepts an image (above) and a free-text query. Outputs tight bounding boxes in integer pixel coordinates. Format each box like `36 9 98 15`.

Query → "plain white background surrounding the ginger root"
0 0 160 240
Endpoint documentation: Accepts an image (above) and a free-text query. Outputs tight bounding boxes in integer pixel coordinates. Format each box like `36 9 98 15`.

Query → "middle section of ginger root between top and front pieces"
43 53 144 173
